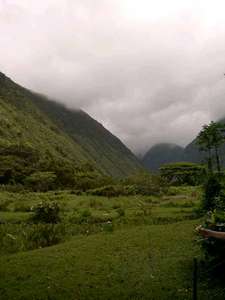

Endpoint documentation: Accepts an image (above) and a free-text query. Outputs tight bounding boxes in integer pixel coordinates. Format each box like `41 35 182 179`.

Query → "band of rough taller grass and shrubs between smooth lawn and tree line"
0 187 198 254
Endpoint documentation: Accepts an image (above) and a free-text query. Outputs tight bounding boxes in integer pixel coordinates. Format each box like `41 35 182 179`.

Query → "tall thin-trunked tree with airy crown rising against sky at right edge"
197 121 225 173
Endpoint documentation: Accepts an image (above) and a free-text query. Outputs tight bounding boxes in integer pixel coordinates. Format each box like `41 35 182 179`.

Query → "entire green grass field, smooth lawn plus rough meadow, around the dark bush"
0 188 224 300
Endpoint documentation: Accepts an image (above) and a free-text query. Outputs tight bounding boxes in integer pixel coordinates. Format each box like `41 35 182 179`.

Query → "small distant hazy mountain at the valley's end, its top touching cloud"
142 143 183 171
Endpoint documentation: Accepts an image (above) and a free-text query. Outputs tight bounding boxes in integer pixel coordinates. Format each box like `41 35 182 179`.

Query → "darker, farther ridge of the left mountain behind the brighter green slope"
36 98 141 175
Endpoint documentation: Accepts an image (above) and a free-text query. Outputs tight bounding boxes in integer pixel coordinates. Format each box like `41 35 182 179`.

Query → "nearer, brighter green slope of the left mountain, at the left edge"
0 98 88 162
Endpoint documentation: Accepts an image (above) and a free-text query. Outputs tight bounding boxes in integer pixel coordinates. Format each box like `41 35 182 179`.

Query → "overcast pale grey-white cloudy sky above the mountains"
0 0 225 153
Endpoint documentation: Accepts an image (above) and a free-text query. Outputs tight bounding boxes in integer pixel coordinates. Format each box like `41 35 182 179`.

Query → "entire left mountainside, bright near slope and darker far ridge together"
0 73 141 176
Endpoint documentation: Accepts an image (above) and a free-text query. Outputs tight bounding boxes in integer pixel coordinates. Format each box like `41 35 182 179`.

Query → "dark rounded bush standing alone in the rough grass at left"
31 201 60 224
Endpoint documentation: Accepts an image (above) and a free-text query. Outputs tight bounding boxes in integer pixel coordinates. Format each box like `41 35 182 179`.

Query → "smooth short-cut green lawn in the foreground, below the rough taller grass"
0 221 198 300
